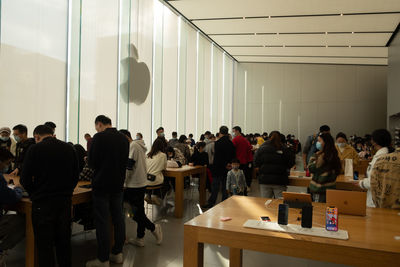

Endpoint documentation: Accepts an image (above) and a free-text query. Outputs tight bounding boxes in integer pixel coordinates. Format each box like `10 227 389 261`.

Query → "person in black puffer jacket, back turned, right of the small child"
254 131 295 198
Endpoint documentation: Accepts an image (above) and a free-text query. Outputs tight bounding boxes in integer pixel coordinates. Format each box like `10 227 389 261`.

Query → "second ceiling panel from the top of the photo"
194 14 400 34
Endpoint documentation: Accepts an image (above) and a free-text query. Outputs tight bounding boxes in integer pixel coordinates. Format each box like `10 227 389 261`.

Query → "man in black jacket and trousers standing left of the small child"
203 126 236 209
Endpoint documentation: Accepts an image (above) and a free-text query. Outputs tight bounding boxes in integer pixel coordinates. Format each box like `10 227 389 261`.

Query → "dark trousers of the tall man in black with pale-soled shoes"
93 192 125 262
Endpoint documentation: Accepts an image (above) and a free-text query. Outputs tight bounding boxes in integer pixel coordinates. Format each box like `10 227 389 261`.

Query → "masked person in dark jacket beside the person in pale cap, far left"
11 124 35 176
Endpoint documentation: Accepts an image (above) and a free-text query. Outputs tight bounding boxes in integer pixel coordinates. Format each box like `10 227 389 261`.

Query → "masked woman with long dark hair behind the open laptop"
308 133 342 202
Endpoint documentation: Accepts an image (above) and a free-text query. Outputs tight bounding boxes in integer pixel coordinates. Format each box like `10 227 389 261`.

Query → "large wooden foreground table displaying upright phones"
183 196 400 267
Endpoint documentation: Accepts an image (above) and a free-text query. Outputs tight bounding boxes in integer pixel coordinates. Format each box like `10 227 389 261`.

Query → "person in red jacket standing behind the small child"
232 126 253 195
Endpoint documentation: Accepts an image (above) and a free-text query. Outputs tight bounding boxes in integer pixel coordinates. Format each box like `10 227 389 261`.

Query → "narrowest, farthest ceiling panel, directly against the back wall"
236 56 387 65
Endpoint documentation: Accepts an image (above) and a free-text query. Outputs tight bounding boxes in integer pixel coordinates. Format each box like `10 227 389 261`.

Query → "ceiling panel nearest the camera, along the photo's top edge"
169 0 400 19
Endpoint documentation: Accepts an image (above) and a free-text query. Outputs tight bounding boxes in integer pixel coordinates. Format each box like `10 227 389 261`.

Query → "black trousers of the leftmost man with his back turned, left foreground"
32 197 71 267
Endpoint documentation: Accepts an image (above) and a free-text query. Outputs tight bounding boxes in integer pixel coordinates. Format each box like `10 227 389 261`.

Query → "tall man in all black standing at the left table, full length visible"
86 115 129 267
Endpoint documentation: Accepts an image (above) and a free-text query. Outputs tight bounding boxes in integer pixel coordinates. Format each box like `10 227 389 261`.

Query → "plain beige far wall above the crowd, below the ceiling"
233 63 387 141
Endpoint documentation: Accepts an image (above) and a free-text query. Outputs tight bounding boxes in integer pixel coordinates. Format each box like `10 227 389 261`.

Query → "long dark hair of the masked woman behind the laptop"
319 133 342 174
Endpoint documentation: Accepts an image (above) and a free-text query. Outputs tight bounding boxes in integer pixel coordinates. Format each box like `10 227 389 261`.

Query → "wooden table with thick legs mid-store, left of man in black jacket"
163 165 207 218
